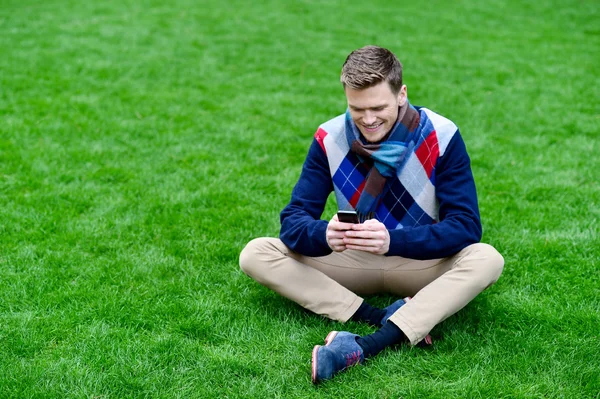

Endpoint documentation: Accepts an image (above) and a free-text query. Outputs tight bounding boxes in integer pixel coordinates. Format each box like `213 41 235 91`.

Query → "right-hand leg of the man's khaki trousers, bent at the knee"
385 244 504 345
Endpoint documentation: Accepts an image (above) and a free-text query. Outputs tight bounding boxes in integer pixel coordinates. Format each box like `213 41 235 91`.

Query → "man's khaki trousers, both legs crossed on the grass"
240 238 504 345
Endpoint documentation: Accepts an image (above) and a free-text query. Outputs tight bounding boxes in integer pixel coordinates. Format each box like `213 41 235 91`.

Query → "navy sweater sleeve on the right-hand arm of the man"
386 132 482 259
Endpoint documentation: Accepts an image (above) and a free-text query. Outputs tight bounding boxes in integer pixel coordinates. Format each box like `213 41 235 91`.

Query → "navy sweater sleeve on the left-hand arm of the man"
279 140 333 256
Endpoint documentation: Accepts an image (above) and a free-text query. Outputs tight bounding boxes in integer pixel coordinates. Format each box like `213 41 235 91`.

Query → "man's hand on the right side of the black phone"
342 219 390 255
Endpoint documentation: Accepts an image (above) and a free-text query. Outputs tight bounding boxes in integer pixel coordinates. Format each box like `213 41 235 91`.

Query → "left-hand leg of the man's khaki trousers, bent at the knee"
240 238 385 321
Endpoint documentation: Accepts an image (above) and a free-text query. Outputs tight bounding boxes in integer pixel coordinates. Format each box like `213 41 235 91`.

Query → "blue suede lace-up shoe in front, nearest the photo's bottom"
312 331 365 384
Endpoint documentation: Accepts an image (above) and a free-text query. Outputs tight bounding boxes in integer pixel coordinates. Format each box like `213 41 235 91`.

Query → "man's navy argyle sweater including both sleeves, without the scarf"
280 107 481 259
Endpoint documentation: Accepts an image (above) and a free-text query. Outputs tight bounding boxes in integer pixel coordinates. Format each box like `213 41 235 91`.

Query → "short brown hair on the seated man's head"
340 46 402 94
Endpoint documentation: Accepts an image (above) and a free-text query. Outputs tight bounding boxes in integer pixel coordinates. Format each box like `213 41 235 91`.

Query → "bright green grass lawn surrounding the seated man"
0 0 600 399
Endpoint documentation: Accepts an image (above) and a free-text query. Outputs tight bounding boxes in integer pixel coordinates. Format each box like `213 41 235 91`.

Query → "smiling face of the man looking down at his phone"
344 81 406 143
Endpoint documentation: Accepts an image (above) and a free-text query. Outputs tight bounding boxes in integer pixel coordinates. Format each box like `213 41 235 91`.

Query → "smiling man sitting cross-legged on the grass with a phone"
240 46 504 383
